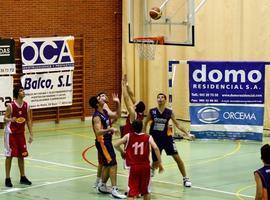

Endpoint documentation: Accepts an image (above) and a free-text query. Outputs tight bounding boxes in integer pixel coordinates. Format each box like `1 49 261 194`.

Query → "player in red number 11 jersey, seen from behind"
114 119 163 200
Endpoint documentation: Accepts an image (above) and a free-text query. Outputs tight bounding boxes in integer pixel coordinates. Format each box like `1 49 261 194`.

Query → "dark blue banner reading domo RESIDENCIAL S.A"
188 61 266 104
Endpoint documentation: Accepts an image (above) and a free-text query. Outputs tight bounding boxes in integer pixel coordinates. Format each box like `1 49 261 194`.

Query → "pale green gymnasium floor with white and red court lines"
0 120 270 200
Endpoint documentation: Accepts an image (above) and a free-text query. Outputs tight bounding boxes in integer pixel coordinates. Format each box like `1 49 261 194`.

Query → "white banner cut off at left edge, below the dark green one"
0 76 13 122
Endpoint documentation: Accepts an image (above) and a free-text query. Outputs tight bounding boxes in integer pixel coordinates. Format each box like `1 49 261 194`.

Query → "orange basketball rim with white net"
133 36 164 60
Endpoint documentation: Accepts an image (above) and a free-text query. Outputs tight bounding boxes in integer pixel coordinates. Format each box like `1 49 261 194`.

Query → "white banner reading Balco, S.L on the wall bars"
21 71 73 109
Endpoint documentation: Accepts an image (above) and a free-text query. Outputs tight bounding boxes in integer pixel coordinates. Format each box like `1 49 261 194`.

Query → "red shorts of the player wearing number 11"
128 165 150 197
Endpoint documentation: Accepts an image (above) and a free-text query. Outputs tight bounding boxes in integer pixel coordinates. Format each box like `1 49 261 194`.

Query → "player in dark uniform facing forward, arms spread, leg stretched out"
144 93 194 187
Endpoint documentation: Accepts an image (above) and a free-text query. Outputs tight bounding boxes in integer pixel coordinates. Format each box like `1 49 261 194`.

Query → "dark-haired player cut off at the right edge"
254 144 270 200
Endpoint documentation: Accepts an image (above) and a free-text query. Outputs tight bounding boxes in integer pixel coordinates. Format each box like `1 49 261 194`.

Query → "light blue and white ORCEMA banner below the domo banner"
190 104 264 141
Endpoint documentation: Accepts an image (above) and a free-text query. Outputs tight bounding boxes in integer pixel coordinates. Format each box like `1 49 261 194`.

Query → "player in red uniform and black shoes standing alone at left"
4 86 33 187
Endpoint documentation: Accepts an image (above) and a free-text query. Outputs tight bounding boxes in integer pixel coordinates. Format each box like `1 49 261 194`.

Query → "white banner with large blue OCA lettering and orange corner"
20 36 74 73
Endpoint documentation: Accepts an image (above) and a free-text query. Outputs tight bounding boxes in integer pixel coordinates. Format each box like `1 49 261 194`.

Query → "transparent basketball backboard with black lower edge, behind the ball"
128 0 195 46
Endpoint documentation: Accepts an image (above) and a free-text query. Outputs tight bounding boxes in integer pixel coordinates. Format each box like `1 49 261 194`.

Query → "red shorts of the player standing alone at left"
5 133 28 157
